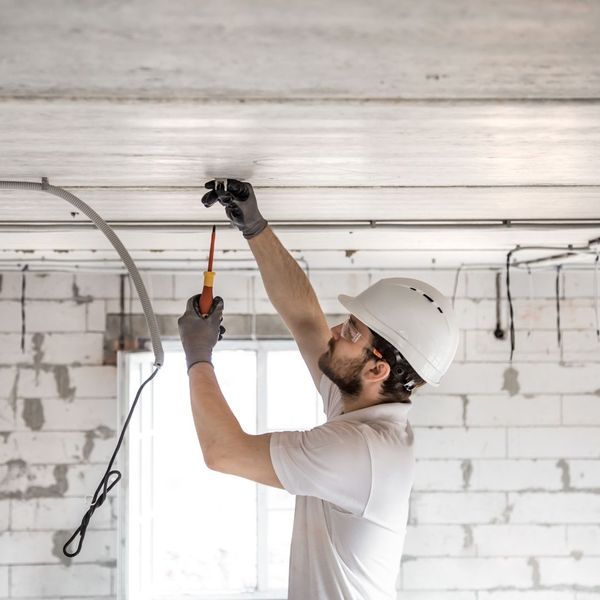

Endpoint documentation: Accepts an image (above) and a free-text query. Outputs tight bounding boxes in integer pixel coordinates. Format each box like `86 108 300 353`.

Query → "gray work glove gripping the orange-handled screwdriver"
177 294 225 373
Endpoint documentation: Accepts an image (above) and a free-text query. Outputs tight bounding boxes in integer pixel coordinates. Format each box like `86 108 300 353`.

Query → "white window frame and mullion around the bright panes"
116 339 310 600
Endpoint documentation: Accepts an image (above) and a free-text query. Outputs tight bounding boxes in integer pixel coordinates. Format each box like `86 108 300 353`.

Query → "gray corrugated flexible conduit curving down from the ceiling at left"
0 177 165 367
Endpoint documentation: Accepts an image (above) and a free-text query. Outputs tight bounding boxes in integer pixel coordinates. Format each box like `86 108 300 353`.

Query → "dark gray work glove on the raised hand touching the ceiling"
202 179 269 240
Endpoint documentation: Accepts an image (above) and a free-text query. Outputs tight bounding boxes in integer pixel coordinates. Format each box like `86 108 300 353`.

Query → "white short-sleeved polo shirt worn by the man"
270 375 414 600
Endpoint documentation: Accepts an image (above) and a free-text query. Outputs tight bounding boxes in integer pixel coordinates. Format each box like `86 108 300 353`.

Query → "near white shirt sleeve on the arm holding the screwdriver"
270 421 372 516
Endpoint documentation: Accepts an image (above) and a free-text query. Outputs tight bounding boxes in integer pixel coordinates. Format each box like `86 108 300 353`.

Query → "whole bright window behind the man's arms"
117 340 325 600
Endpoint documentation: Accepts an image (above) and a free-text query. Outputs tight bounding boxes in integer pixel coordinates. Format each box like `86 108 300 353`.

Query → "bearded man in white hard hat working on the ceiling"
179 179 458 600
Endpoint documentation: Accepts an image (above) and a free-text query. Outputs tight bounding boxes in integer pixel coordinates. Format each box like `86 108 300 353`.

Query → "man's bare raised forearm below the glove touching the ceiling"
248 226 321 322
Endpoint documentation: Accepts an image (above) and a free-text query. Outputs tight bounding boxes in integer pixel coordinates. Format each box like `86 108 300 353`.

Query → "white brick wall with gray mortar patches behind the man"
0 269 600 600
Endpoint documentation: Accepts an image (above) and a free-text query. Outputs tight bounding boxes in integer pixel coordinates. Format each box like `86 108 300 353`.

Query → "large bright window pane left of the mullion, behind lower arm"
149 350 257 598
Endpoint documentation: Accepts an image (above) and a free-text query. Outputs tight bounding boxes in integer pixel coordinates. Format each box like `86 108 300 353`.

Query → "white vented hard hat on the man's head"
338 277 459 386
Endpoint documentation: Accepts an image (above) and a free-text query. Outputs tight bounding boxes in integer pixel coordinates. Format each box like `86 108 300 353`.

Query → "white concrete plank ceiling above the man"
0 0 600 269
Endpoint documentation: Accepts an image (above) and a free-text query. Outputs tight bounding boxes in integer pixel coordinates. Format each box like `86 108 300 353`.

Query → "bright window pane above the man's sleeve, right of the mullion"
267 350 323 431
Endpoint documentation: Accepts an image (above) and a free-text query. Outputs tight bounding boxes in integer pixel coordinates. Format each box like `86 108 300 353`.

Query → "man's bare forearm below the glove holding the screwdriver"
189 362 243 466
